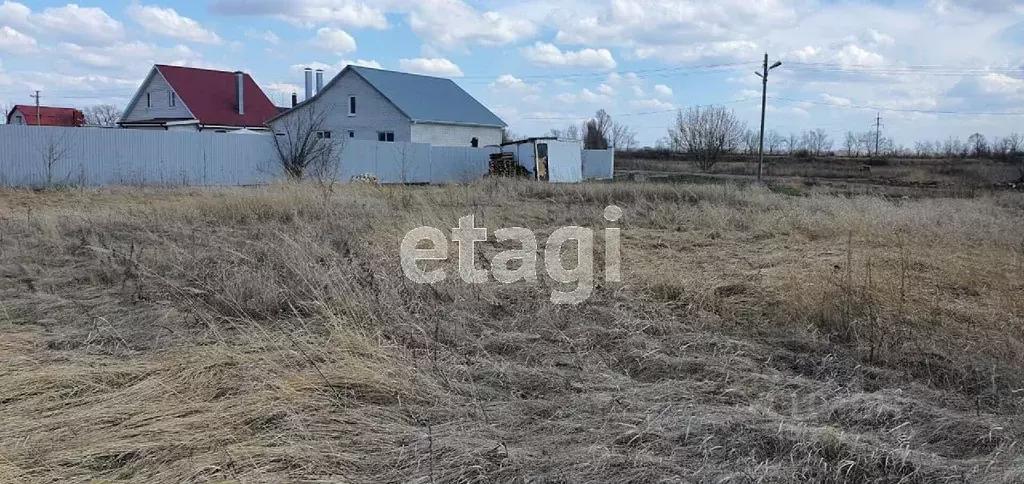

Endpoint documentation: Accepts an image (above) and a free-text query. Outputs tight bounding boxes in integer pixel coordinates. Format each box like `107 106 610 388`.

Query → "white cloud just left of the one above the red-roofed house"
31 3 124 44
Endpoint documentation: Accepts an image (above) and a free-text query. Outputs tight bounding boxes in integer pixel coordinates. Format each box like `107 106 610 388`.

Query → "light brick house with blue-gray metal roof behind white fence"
269 65 506 146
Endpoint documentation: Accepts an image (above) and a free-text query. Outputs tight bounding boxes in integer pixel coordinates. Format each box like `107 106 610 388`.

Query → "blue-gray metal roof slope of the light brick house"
350 65 507 127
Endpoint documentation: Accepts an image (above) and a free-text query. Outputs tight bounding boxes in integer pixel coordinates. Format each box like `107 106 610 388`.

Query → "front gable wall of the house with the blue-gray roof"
272 72 412 142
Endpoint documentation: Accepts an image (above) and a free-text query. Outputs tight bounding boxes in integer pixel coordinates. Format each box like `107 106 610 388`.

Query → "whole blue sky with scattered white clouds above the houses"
0 0 1024 146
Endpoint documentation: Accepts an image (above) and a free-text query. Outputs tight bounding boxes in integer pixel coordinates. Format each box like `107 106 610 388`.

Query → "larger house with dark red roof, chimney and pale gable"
118 64 278 131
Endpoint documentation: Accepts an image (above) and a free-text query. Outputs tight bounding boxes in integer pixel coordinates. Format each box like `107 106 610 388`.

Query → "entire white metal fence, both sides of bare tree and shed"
0 125 611 186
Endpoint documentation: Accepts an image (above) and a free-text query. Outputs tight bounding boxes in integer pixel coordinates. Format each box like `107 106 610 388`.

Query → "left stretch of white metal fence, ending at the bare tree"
0 125 281 186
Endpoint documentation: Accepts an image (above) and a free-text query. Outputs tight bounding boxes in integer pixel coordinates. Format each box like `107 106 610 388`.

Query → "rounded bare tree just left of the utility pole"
669 106 746 171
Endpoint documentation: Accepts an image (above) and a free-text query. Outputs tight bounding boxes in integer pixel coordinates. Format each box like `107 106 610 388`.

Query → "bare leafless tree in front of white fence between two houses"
271 105 345 179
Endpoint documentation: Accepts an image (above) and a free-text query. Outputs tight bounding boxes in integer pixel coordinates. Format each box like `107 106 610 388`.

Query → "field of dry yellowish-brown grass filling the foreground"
0 181 1024 484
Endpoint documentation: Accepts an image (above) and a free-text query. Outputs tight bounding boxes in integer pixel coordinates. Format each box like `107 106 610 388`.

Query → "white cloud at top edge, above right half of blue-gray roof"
409 0 537 48
